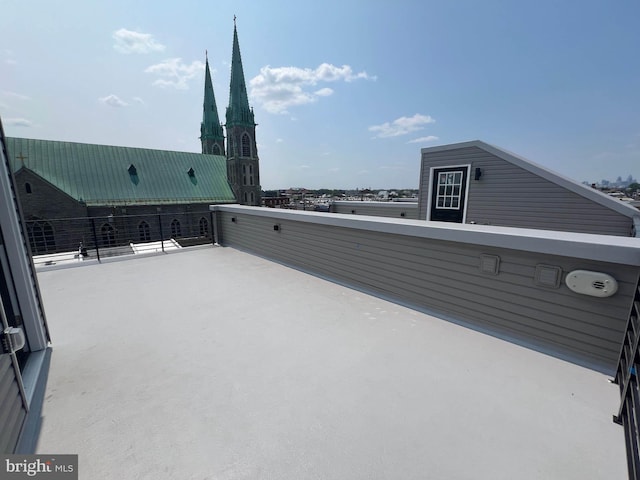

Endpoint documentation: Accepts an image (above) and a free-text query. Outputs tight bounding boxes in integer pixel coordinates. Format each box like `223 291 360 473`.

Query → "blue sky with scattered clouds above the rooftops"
0 0 640 189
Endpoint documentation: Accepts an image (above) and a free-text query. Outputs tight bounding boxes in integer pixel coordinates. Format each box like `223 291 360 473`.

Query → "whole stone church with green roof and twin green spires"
7 22 261 254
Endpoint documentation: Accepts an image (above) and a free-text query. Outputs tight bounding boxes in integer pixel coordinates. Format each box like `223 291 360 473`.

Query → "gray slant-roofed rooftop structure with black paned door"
418 140 640 236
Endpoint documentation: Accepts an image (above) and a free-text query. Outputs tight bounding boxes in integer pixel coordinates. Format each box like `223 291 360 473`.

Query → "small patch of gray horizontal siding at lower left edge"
0 354 27 453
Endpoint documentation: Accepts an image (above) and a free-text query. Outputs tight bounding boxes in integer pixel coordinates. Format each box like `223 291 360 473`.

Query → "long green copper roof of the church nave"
7 137 235 206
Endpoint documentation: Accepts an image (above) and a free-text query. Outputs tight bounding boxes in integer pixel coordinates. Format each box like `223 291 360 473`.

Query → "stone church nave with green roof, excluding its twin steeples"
7 138 236 254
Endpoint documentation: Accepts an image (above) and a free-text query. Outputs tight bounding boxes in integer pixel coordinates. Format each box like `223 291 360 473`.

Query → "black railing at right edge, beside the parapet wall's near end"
613 282 640 480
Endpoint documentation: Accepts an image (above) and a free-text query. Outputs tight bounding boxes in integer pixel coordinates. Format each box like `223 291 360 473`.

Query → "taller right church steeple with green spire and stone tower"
225 17 262 206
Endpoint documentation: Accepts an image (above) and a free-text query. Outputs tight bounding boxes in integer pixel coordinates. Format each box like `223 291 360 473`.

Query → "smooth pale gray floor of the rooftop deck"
33 247 626 480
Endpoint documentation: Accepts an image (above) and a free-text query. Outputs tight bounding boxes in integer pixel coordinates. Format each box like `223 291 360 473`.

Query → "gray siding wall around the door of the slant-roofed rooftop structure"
418 147 632 236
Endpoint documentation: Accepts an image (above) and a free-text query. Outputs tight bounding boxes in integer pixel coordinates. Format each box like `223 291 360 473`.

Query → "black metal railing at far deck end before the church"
25 211 215 265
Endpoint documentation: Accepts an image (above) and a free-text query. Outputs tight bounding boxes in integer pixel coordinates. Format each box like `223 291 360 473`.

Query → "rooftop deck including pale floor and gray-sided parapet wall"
38 206 640 479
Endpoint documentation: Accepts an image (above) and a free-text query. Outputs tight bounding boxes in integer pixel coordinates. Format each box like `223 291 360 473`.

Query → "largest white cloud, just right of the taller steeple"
249 63 376 113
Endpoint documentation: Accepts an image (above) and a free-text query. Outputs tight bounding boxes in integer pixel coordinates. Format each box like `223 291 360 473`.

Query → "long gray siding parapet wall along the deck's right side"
211 207 640 374
